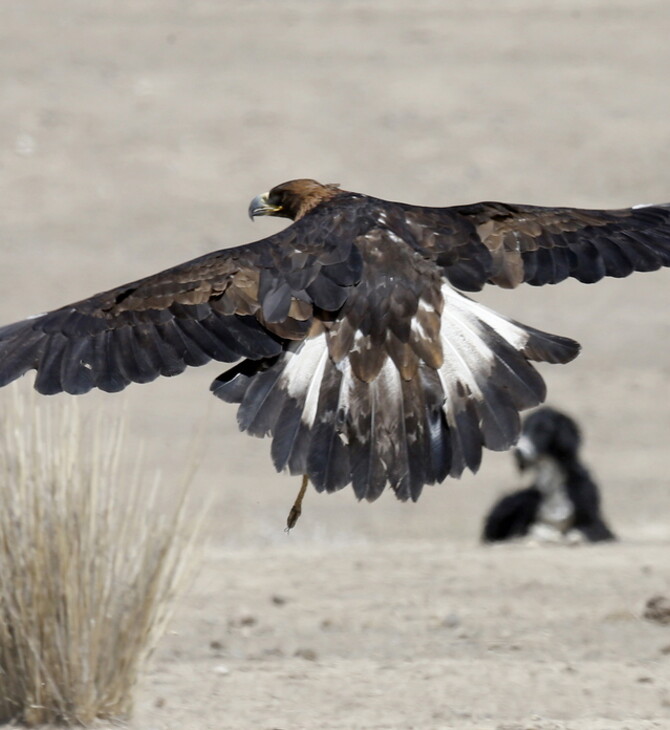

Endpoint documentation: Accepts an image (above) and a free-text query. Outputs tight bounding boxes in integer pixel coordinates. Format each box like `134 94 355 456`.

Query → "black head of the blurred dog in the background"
514 406 581 470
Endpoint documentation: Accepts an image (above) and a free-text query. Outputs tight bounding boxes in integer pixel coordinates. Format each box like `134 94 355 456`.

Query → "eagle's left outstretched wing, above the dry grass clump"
0 206 362 394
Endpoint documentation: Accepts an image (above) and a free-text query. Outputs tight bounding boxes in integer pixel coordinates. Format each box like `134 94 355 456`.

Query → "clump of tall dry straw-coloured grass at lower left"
0 389 201 725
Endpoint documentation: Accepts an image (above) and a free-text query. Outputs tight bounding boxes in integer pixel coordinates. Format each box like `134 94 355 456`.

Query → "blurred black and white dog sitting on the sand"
482 407 616 542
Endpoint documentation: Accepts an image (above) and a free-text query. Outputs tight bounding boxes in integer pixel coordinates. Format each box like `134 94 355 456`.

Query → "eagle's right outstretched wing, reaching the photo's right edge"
386 203 670 291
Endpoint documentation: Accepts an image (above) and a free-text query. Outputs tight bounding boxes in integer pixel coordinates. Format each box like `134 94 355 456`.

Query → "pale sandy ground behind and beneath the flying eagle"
0 0 670 730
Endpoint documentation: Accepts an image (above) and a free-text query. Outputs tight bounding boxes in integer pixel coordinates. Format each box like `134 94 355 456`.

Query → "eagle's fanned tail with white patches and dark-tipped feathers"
213 285 576 500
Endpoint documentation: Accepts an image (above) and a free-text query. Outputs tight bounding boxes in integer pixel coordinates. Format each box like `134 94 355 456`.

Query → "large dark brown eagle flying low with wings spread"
0 180 670 500
